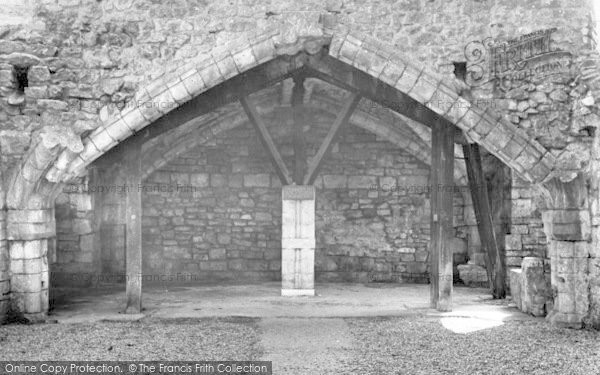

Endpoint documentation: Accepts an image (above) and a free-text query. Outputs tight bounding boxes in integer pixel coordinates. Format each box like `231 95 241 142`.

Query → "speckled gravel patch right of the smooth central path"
347 315 600 375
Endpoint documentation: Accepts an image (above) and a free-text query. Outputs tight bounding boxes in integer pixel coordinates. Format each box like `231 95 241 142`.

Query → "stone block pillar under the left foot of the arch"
7 206 56 321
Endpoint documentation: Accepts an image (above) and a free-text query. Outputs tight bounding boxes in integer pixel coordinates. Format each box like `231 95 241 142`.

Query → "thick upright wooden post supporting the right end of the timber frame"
430 119 454 311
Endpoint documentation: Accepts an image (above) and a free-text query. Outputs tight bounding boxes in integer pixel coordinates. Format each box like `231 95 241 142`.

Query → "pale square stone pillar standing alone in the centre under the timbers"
281 185 316 296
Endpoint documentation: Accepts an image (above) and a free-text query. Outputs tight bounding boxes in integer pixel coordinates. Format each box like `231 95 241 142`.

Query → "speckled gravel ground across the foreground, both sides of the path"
0 313 600 375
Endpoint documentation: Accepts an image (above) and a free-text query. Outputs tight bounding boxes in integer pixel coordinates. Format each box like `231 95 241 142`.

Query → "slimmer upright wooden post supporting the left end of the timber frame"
125 144 142 314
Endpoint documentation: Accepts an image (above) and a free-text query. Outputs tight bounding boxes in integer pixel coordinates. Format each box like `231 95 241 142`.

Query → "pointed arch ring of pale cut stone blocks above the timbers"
7 22 555 208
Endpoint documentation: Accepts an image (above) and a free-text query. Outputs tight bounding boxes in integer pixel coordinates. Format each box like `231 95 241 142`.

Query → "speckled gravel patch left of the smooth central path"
0 317 262 361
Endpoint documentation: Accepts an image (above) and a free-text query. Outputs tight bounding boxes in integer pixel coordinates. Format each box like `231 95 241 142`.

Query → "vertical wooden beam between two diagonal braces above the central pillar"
291 75 306 185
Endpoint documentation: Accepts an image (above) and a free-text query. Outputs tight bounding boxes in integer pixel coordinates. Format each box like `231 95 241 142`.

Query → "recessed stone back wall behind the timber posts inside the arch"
63 108 466 282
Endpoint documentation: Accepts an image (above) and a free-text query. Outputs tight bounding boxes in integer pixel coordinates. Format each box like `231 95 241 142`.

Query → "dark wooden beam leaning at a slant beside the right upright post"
463 144 506 298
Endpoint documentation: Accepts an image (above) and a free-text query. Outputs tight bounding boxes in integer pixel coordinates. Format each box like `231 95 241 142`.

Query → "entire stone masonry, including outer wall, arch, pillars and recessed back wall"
0 0 600 327
